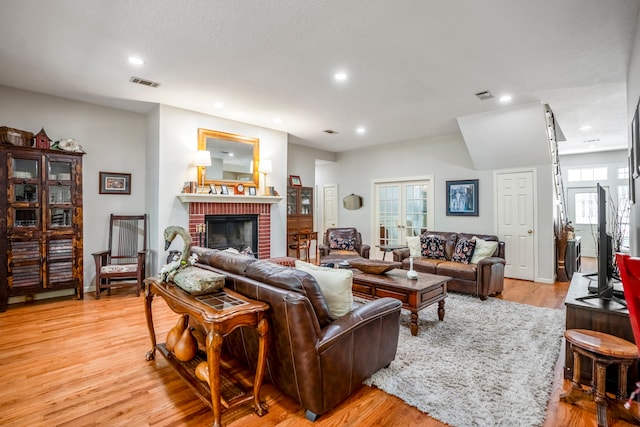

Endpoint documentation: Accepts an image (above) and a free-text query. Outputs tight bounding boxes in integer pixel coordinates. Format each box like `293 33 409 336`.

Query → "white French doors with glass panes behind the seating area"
372 178 434 258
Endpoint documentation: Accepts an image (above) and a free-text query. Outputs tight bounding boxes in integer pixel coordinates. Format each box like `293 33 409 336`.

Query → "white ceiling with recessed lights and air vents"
0 0 640 154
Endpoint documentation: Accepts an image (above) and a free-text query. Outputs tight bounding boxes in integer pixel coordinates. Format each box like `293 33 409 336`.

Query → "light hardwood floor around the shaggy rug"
0 262 629 427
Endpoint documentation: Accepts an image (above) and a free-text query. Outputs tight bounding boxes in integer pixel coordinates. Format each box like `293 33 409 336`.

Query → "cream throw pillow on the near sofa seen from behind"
296 260 353 319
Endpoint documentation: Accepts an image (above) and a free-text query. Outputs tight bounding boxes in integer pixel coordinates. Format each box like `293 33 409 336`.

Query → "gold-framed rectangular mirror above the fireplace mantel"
198 128 260 187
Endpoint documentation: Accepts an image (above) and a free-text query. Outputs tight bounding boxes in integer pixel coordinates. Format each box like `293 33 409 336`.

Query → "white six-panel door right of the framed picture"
496 172 535 280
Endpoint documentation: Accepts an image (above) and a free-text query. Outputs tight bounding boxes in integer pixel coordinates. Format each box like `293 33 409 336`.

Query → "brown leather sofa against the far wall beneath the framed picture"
393 231 505 300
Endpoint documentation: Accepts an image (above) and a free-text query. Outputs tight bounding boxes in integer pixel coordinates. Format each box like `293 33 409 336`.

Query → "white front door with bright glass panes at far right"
567 187 596 257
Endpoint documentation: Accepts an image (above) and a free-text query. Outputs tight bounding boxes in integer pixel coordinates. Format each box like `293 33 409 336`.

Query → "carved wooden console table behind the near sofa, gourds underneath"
144 277 269 427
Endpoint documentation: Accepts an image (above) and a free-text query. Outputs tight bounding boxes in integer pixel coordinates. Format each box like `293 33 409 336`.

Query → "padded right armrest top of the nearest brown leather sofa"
318 298 402 352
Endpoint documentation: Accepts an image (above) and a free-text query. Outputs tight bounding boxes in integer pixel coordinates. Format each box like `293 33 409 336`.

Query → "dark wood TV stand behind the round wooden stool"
564 273 638 390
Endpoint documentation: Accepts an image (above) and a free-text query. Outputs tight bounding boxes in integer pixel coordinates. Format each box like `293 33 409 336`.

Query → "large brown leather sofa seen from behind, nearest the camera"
191 247 401 421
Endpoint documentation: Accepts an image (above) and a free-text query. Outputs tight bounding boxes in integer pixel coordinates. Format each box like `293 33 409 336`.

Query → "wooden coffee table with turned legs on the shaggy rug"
353 269 451 336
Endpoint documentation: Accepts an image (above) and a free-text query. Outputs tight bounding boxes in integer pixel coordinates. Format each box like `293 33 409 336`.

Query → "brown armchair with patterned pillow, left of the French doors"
318 227 371 263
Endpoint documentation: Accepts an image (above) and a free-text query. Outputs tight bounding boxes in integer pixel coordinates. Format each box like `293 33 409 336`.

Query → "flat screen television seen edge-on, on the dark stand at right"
576 183 626 307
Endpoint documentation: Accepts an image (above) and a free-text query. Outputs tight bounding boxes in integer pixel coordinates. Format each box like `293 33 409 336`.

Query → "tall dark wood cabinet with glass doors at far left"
0 145 83 311
